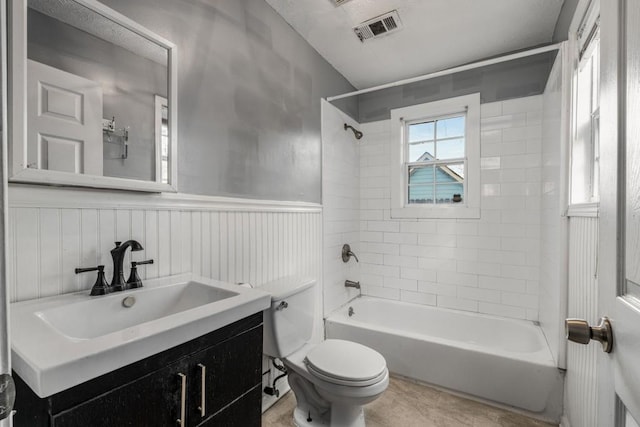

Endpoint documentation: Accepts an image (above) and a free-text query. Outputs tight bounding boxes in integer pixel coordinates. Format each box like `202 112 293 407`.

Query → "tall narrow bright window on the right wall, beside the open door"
570 10 600 205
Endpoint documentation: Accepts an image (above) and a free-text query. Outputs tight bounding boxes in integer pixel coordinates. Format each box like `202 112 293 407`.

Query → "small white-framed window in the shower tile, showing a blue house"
384 94 480 218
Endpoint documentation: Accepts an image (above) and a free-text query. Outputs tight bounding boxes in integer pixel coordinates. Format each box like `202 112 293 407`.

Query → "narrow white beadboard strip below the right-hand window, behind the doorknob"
564 217 602 427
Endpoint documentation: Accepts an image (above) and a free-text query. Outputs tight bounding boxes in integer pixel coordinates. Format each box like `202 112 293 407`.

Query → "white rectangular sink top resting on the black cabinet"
10 275 271 397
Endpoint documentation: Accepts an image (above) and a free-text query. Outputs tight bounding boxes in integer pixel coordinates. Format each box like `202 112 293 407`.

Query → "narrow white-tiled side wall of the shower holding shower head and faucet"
322 101 362 315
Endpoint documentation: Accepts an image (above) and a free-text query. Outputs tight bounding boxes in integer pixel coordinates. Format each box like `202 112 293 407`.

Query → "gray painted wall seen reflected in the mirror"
27 9 167 181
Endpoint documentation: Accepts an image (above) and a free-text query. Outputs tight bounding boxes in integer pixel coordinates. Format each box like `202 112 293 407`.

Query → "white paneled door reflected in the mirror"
27 60 103 175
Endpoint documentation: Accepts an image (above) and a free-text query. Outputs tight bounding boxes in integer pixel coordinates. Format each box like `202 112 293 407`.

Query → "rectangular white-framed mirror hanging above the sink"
9 0 177 191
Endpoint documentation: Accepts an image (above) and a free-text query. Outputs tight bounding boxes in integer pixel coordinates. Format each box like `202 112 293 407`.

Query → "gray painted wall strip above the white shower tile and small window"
358 51 557 123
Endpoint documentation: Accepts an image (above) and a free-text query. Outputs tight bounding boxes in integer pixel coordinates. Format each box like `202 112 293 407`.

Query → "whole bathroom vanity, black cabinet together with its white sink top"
11 275 270 427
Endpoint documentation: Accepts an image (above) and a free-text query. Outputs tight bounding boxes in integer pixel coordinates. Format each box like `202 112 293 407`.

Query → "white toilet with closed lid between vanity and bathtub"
261 277 389 427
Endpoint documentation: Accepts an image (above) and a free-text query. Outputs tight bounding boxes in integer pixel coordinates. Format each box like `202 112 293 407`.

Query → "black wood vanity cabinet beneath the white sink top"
14 312 262 427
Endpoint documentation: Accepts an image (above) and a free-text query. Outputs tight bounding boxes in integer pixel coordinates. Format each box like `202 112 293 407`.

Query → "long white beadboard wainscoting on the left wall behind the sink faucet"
9 189 322 302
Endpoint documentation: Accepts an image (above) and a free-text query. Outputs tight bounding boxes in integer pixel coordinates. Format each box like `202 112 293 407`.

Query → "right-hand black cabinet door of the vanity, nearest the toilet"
189 326 262 425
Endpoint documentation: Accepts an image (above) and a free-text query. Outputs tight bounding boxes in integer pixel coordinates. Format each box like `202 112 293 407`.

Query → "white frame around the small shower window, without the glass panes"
389 93 480 219
